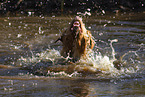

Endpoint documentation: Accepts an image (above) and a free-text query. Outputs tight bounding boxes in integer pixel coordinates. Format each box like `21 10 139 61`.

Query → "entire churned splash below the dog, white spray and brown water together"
17 39 142 78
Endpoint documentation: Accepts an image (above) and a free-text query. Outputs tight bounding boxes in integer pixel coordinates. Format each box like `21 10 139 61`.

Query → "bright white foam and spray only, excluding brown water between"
16 39 139 77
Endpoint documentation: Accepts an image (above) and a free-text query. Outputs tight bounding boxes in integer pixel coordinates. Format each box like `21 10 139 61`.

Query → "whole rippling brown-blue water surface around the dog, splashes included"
0 13 145 97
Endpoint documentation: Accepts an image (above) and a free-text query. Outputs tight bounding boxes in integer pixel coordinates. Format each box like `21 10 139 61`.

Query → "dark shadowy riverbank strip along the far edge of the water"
0 0 145 16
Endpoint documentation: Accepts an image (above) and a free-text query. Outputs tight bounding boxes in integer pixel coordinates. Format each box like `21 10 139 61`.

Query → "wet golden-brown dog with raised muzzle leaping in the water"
56 16 95 61
